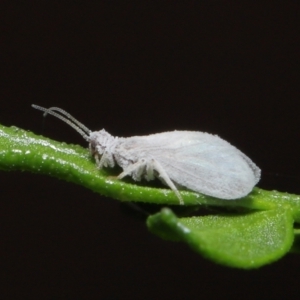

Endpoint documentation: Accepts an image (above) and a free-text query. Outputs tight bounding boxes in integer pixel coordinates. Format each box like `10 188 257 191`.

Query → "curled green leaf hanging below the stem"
147 208 294 269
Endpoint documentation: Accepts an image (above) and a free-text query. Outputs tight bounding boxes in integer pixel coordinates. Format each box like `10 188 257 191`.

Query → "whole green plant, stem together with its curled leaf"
0 125 300 269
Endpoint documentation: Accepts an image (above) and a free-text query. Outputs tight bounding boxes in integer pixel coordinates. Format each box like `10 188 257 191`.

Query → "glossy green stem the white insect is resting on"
0 125 300 211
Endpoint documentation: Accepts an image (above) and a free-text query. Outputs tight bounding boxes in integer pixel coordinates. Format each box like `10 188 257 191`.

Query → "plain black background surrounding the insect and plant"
0 1 300 299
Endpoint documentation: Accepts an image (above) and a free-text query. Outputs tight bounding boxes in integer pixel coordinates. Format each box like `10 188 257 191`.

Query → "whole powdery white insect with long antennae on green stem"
32 104 261 204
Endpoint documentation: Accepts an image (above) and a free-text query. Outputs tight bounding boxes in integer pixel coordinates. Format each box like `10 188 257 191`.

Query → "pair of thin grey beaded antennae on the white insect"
31 104 91 141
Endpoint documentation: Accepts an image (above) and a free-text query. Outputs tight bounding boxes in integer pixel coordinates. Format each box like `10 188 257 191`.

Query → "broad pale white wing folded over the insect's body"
118 131 260 199
